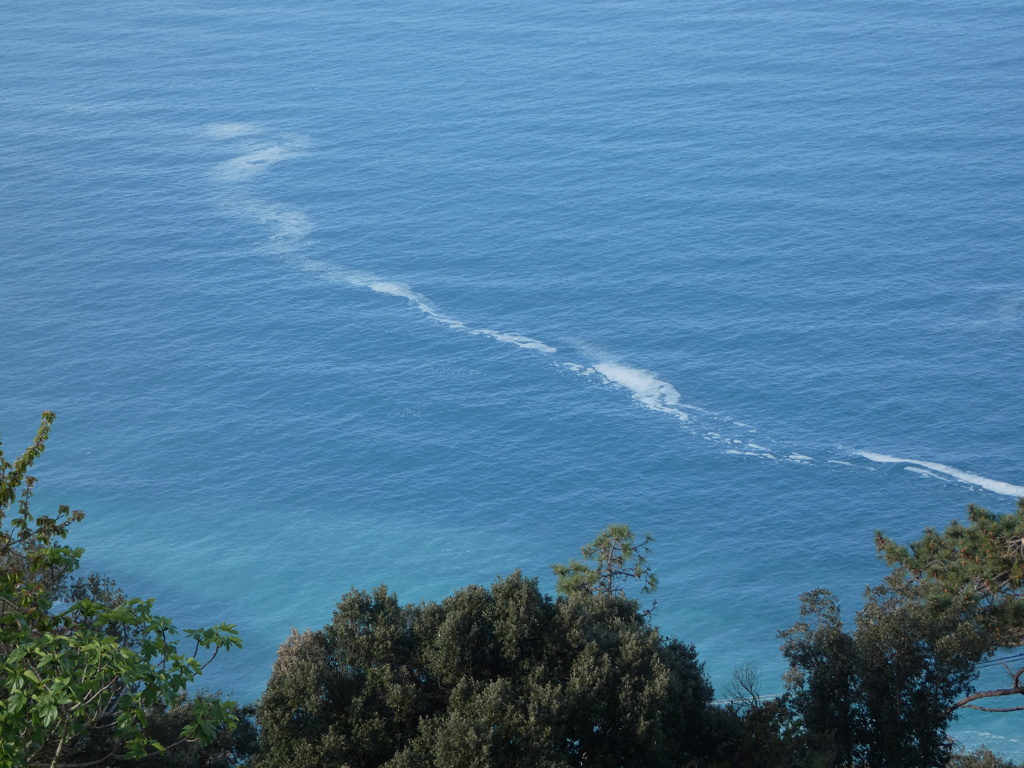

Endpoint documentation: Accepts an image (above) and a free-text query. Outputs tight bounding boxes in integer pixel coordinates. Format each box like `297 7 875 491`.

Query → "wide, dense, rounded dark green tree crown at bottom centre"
257 572 712 768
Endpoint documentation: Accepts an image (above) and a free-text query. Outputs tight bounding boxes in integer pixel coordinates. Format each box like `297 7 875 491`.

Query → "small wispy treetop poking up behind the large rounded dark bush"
551 524 657 597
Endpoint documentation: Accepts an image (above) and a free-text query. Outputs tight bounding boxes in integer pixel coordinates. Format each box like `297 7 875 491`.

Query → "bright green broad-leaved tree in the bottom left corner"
0 412 241 768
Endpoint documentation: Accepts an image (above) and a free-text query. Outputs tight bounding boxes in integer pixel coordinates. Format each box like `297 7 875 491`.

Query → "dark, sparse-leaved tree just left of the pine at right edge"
780 571 984 768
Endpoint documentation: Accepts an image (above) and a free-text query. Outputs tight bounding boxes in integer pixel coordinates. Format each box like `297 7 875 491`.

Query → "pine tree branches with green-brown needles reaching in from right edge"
877 499 1024 712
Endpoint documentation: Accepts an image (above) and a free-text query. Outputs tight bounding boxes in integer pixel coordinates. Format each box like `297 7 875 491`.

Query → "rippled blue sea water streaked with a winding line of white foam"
0 0 1024 756
